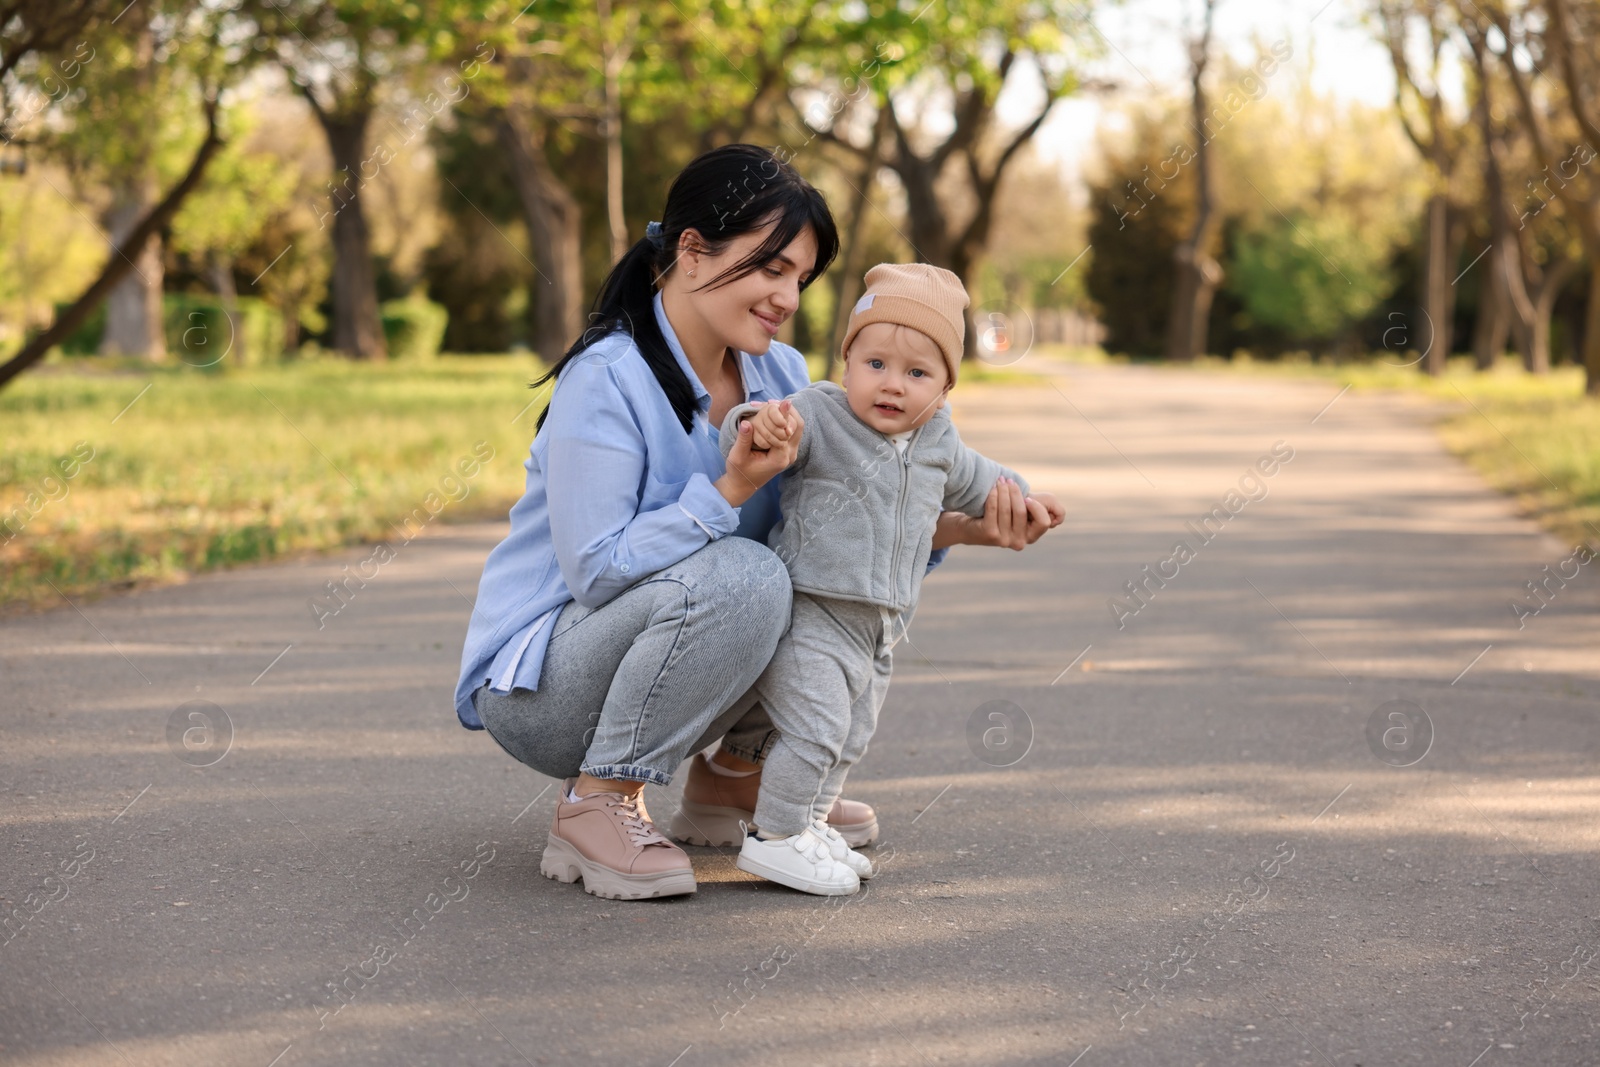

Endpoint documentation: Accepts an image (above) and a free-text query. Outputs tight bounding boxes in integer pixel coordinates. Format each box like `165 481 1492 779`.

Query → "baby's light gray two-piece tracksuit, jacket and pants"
720 382 1027 837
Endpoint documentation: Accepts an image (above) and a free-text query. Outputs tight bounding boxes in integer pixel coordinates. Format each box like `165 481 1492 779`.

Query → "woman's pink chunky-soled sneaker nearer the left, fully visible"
539 779 696 901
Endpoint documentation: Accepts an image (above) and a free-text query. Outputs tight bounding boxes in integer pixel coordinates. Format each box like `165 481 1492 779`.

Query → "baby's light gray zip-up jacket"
720 382 1029 611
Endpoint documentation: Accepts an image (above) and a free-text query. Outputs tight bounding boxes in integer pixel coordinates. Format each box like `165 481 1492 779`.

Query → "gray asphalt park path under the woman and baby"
0 362 1600 1067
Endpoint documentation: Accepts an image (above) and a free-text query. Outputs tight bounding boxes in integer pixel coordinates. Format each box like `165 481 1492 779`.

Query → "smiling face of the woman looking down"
674 226 816 355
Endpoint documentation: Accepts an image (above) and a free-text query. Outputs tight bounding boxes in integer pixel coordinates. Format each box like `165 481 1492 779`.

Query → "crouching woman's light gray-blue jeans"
472 536 790 785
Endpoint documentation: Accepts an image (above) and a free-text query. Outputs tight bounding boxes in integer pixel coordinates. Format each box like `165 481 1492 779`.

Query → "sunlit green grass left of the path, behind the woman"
0 357 544 608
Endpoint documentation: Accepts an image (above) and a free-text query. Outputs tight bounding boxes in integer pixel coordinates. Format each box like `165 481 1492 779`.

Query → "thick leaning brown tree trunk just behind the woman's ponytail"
499 109 584 363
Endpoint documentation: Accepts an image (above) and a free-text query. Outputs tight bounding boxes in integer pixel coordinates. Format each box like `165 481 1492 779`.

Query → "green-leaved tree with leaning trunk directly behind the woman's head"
475 0 826 358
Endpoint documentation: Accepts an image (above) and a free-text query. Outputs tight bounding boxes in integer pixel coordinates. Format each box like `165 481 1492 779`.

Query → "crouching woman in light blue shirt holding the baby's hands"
456 144 1059 899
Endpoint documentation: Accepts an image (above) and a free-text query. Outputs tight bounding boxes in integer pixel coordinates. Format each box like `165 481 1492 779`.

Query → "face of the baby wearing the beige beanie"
845 322 950 434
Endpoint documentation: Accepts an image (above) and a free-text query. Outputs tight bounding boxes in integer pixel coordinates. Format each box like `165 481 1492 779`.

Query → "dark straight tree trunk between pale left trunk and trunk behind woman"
317 110 389 360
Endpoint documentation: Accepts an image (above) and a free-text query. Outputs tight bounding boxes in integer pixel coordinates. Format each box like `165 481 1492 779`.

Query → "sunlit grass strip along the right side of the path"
1030 350 1600 547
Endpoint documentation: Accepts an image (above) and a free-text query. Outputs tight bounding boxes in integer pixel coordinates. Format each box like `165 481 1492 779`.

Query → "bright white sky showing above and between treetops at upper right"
1000 0 1395 179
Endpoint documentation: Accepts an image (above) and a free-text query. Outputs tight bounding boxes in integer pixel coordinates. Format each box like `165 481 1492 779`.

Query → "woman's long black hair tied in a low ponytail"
533 144 838 434
